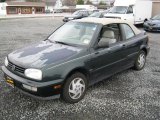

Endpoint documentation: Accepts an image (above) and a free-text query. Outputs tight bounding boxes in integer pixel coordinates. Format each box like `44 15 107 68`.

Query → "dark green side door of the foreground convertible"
90 24 126 83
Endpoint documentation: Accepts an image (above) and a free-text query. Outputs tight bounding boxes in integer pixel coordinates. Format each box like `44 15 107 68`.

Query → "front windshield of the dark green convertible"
48 22 98 45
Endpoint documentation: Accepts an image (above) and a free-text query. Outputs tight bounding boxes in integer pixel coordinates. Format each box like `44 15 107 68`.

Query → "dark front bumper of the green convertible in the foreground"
2 66 63 100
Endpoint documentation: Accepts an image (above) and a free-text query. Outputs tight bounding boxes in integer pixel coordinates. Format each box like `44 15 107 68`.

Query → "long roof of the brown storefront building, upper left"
6 1 45 7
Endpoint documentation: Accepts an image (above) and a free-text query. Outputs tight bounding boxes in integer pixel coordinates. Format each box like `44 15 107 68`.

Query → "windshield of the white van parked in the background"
109 6 128 14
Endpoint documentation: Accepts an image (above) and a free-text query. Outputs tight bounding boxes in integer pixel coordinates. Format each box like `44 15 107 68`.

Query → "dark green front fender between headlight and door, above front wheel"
43 55 90 81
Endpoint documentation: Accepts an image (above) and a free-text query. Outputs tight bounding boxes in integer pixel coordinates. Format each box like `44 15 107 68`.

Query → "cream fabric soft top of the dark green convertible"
74 18 141 35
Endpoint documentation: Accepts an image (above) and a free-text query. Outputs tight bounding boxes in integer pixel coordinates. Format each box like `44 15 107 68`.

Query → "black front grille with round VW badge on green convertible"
8 62 25 74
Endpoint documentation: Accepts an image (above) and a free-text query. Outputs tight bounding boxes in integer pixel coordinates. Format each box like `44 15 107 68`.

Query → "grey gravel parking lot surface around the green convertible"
0 17 160 120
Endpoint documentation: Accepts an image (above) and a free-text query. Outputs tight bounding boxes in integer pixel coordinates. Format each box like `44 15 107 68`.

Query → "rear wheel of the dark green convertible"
134 50 146 70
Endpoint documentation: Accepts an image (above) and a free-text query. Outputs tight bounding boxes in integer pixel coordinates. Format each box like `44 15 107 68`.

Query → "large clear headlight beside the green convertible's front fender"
24 69 42 80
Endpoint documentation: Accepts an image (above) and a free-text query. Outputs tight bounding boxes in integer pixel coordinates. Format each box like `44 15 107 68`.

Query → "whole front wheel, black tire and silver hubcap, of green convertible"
62 72 87 104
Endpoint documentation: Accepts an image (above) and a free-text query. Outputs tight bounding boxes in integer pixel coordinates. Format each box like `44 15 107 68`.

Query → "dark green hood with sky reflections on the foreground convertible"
8 41 81 68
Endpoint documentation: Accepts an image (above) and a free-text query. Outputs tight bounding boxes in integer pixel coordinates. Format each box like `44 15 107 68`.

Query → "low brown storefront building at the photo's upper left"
0 0 45 15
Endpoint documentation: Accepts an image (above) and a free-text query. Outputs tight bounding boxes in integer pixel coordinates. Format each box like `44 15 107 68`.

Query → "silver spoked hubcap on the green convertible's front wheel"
69 78 85 99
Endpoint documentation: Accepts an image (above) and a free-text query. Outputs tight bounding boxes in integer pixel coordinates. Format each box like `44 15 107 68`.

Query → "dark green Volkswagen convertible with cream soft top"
2 18 149 103
